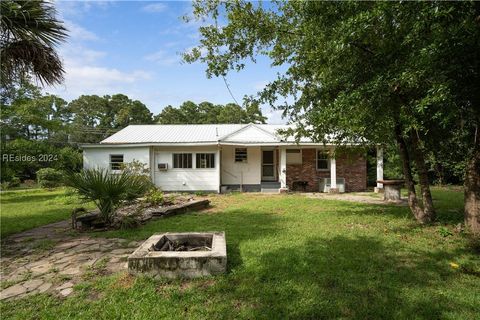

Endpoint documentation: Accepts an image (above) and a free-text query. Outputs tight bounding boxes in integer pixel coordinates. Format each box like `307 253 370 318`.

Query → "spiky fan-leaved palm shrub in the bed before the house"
66 169 152 224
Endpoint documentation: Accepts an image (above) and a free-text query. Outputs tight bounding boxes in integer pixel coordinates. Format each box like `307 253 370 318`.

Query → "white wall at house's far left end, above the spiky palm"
83 147 150 169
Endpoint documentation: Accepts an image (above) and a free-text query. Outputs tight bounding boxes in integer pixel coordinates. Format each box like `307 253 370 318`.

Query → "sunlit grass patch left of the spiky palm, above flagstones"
0 188 92 239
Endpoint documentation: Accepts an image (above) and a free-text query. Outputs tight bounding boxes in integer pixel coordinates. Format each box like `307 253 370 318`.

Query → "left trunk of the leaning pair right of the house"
395 123 425 223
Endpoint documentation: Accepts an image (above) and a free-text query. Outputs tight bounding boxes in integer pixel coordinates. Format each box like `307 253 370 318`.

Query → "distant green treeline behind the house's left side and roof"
0 82 266 182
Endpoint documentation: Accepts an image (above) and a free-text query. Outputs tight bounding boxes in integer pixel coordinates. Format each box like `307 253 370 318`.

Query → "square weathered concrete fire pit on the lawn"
128 232 227 278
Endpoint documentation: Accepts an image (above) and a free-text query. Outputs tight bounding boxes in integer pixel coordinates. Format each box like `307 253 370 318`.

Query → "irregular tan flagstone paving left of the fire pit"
0 221 140 300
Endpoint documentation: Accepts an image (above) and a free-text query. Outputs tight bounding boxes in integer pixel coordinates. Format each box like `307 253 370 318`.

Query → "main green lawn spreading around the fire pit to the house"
0 189 480 319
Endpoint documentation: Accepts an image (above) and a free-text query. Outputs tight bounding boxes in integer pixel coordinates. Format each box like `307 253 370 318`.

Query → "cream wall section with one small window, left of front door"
222 146 262 184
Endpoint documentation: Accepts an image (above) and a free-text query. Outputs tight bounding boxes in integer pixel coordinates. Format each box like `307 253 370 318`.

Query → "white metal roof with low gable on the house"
100 124 311 145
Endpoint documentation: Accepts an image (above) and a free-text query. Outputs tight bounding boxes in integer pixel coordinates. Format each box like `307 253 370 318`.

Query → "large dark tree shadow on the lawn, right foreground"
214 236 475 319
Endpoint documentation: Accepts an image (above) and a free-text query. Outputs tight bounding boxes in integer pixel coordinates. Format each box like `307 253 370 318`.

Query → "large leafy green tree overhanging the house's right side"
185 0 480 232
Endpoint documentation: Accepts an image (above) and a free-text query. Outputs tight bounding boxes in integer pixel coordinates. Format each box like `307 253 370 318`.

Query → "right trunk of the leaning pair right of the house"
410 131 435 222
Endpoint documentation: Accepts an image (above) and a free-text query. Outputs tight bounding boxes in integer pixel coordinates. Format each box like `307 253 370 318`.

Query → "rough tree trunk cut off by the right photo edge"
464 127 480 236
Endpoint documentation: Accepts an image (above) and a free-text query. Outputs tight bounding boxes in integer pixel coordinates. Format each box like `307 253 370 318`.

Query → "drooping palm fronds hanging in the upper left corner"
0 0 67 87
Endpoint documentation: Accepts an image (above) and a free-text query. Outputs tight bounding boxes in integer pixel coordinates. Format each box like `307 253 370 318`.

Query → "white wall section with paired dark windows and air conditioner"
153 147 220 192
